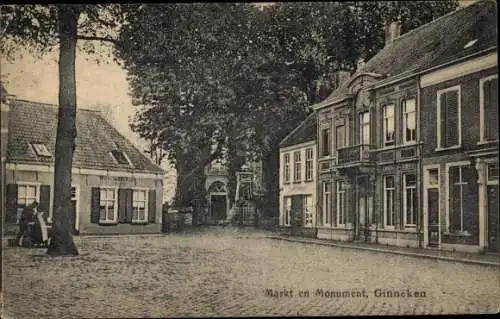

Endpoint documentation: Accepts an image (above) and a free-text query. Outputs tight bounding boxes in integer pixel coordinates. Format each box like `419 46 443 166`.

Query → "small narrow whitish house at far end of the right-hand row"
279 113 317 237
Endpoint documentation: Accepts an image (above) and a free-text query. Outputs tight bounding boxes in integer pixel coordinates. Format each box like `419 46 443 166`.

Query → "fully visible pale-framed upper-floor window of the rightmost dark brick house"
437 86 462 150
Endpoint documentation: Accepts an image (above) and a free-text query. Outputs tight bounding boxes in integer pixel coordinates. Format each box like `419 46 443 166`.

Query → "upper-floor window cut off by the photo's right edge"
479 74 498 142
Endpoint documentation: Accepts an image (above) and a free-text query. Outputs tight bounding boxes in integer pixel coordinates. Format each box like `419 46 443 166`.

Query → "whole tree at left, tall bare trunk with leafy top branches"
0 4 127 256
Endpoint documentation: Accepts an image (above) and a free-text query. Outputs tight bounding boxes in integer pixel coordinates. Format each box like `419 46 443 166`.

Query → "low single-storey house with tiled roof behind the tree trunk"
2 99 164 234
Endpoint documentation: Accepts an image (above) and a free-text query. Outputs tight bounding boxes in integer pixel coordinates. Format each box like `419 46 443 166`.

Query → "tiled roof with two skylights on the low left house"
7 100 164 174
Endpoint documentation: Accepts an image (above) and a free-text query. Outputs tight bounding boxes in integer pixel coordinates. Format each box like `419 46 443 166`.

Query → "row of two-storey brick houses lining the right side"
280 0 500 252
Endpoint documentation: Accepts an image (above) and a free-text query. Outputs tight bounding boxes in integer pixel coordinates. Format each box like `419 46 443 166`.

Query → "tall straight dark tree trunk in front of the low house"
47 5 80 256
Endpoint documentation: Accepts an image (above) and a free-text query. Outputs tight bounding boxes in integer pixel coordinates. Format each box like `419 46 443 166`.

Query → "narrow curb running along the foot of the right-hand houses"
266 236 500 267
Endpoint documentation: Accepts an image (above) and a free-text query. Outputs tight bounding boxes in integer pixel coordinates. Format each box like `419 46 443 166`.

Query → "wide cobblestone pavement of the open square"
2 228 500 318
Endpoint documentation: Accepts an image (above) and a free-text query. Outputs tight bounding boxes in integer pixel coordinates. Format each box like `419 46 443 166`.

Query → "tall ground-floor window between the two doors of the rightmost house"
447 165 478 234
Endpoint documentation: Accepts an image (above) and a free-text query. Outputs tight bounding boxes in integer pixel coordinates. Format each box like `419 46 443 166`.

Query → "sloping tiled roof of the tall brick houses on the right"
322 0 498 104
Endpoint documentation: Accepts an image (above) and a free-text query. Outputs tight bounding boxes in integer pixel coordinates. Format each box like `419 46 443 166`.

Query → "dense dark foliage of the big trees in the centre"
117 1 457 214
